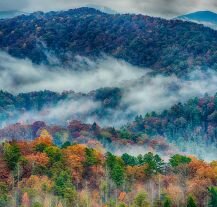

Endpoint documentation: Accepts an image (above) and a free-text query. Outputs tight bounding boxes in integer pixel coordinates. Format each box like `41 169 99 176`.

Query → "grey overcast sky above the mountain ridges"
0 0 217 17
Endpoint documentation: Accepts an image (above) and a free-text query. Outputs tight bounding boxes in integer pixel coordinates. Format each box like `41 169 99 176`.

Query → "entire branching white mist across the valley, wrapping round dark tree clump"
0 52 217 126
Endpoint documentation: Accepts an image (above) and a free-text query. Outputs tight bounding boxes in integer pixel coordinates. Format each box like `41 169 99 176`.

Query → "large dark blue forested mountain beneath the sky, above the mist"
0 8 217 76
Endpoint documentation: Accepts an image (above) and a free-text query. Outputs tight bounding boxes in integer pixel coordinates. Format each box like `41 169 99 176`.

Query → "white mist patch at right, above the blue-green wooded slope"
124 70 217 114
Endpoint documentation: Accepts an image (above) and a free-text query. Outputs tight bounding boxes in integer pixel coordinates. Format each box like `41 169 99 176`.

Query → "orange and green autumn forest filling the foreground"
0 130 217 207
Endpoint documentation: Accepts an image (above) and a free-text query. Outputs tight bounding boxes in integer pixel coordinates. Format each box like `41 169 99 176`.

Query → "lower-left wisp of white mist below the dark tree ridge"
14 98 100 125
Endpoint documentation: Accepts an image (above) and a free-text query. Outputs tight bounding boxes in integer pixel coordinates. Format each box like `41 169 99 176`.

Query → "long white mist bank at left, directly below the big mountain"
0 52 146 93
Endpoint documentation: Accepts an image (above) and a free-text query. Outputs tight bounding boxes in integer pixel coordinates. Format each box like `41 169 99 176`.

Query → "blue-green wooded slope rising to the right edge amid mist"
127 94 217 146
